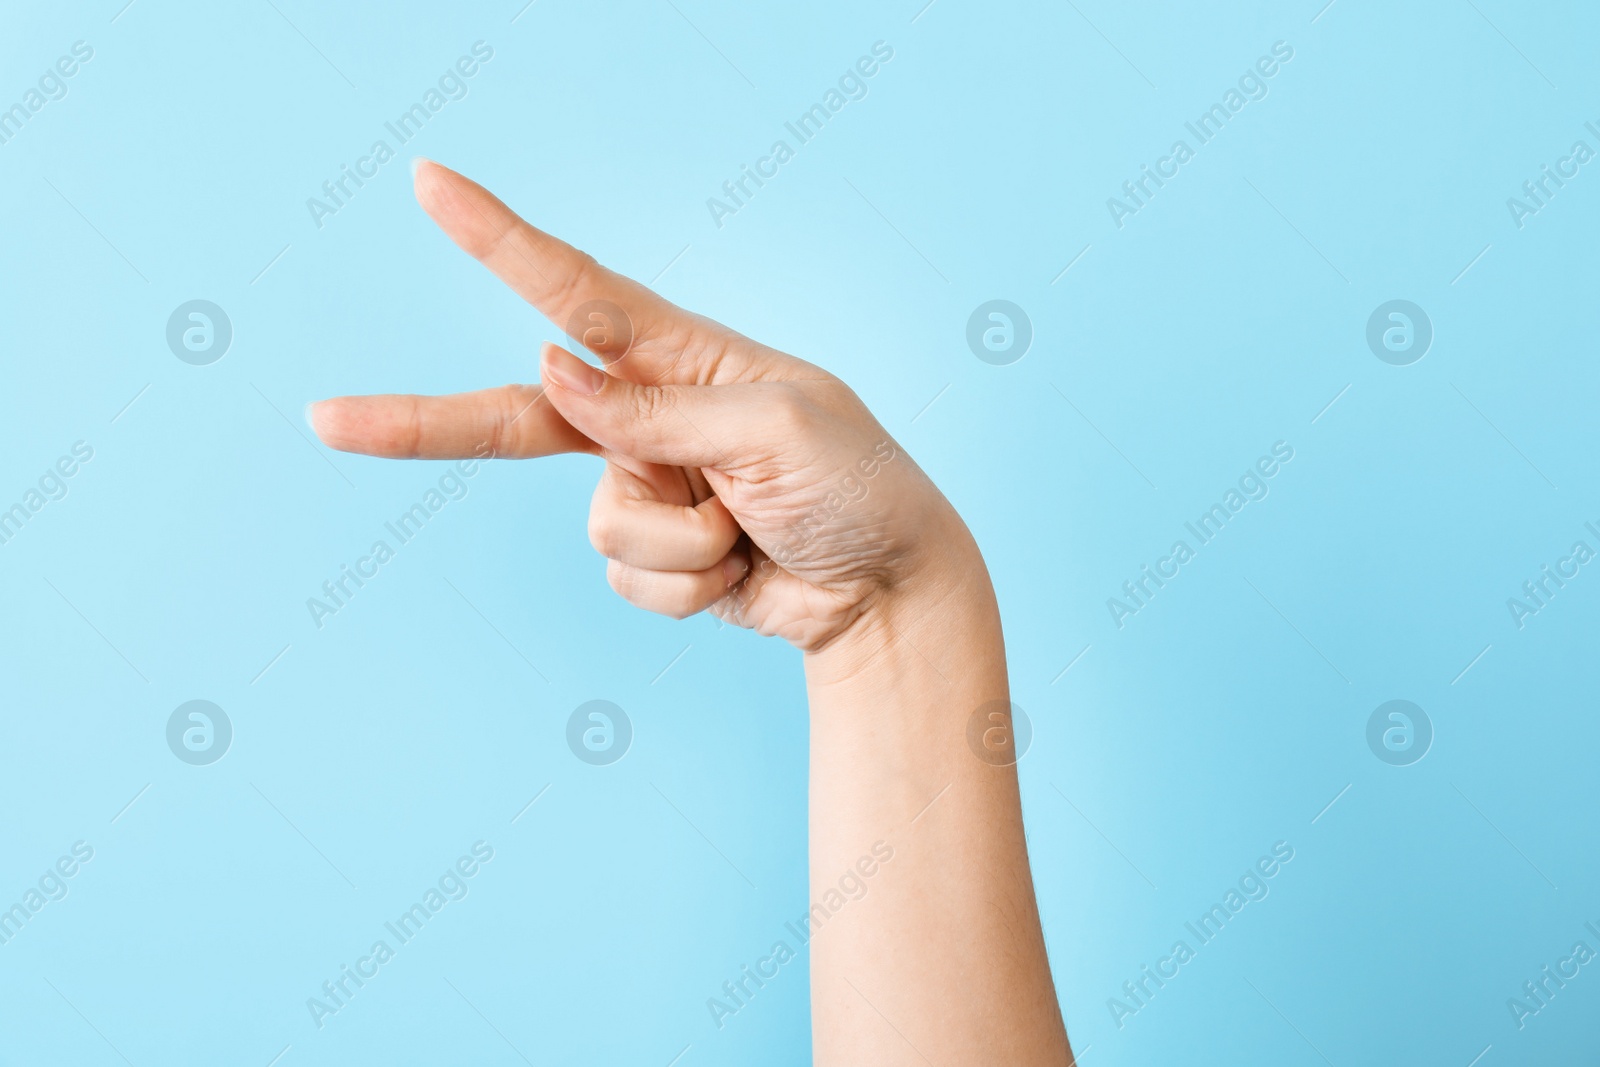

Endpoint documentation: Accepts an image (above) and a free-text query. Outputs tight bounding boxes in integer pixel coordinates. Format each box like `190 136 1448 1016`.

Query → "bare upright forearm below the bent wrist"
806 522 1070 1067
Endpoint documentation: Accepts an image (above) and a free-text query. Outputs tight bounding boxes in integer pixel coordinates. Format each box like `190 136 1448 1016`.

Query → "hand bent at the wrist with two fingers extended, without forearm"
310 160 970 651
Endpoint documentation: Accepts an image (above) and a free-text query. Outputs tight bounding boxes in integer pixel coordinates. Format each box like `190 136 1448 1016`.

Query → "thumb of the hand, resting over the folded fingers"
539 342 749 467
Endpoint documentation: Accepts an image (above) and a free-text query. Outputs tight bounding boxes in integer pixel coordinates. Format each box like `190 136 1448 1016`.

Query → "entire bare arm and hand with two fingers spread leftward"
310 162 1072 1067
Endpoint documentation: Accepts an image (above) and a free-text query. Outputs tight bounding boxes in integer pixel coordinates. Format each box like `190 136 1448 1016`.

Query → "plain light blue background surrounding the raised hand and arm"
0 0 1600 1067
